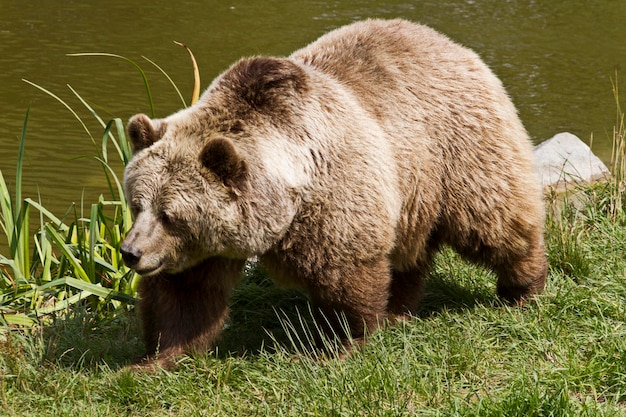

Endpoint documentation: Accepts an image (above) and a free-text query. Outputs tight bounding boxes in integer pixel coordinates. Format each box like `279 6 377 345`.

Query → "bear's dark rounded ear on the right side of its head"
200 138 248 188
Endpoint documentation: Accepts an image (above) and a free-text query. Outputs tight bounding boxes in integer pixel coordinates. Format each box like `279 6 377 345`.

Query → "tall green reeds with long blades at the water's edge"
0 43 200 326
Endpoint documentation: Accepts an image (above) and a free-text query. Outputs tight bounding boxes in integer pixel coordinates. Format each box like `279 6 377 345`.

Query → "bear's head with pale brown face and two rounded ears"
121 115 248 275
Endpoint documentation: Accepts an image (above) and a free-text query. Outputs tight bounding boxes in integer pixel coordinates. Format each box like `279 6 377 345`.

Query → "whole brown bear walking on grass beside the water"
121 20 547 364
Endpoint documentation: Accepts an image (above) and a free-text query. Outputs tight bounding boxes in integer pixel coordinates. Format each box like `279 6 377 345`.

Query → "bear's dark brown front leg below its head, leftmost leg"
138 258 244 367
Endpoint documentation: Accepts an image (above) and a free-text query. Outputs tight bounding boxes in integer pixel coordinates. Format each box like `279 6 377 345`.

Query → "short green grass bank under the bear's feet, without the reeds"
0 189 626 416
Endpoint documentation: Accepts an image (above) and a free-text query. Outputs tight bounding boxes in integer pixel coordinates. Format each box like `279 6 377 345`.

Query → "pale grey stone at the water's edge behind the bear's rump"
535 132 610 189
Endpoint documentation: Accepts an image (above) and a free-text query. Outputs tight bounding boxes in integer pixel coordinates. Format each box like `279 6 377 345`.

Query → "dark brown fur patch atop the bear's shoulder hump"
225 57 308 111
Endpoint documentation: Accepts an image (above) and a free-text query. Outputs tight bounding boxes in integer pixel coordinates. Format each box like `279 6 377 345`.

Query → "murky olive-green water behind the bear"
0 0 626 224
